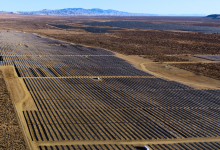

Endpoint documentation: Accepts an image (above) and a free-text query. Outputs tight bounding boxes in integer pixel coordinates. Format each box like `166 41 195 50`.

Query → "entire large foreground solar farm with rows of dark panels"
0 31 220 150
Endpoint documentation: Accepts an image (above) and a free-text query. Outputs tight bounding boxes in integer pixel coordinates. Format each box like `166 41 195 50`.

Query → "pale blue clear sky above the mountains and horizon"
0 0 220 14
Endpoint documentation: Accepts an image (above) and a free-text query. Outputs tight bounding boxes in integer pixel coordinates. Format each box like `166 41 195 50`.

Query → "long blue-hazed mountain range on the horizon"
18 8 156 16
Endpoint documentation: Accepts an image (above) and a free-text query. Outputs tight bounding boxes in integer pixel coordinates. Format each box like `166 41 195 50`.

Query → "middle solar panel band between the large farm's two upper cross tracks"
0 56 152 77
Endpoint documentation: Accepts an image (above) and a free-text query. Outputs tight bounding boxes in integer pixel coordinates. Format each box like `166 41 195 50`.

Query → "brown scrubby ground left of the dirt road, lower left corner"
0 70 28 150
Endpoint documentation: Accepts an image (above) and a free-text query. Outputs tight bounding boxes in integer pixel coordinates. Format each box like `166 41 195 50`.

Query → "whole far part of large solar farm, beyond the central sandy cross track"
0 31 152 77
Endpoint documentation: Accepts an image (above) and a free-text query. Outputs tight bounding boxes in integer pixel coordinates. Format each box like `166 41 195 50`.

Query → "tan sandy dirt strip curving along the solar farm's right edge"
116 53 220 89
